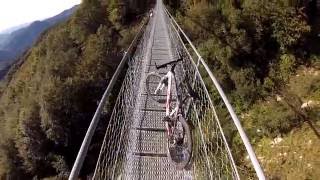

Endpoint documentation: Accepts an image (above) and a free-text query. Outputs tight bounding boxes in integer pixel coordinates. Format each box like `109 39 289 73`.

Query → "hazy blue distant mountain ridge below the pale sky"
0 5 78 79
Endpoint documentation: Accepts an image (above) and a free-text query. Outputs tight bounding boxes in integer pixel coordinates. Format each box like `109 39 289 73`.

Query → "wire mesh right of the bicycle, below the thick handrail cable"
162 4 239 179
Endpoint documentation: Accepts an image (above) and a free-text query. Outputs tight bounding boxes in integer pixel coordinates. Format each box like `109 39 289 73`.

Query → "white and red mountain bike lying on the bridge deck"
146 56 192 169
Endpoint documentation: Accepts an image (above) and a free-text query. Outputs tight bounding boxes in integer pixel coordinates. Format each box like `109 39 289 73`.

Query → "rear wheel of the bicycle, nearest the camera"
167 115 192 170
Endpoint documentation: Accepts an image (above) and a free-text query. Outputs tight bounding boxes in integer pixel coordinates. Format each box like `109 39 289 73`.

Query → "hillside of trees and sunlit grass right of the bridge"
165 0 320 179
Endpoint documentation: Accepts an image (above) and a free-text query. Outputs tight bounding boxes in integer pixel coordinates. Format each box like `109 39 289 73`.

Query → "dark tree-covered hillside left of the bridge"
0 0 150 179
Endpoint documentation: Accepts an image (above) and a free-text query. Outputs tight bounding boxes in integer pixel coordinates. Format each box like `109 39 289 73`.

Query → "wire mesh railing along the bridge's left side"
93 15 151 179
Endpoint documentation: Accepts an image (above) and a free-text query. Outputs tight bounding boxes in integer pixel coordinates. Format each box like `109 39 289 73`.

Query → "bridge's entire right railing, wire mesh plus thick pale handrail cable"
164 3 265 179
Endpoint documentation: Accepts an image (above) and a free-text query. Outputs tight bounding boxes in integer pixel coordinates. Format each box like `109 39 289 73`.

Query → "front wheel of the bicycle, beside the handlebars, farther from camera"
146 72 168 106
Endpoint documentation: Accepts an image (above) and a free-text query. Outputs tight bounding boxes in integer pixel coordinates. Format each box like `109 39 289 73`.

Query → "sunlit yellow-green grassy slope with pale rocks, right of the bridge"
243 64 320 179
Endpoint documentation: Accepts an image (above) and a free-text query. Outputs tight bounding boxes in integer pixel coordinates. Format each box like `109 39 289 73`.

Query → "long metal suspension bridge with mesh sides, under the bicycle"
69 0 265 179
